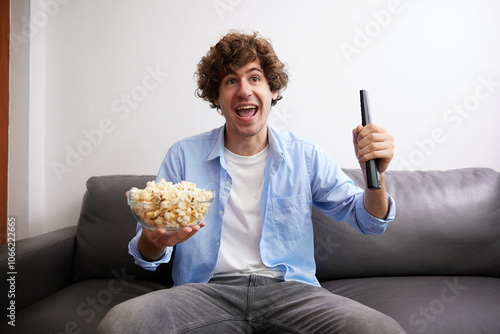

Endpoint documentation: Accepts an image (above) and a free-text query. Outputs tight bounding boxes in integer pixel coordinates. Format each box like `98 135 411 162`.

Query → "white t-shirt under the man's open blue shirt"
214 147 283 277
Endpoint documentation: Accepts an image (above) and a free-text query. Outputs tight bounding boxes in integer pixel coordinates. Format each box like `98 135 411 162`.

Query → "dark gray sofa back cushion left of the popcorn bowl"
73 175 172 285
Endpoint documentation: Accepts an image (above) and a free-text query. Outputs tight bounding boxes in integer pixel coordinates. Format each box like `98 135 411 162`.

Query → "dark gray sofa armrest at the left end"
0 226 76 318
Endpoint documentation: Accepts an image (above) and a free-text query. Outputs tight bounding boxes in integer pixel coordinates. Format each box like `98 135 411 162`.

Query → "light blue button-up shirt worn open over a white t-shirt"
129 126 395 286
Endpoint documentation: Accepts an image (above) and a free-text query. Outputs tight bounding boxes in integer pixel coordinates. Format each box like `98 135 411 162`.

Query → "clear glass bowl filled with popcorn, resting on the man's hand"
127 190 215 231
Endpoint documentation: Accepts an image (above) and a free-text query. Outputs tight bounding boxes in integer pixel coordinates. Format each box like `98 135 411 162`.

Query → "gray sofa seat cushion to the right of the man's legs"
322 276 500 334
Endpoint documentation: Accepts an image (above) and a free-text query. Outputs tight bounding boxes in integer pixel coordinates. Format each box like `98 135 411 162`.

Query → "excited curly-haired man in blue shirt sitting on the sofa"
99 32 404 334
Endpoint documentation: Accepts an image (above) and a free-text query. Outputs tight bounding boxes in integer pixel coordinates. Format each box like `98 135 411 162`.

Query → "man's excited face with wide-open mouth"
214 61 278 144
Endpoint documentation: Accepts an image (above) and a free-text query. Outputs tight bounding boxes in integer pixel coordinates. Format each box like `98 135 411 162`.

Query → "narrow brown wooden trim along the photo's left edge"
0 0 10 244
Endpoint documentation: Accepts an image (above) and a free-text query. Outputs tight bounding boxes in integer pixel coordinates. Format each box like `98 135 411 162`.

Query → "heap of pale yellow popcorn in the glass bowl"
129 179 212 228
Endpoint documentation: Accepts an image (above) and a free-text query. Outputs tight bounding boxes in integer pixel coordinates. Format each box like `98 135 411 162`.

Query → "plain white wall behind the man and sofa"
9 0 500 240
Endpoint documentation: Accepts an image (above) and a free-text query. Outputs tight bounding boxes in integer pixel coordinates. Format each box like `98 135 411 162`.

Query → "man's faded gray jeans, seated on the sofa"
97 275 404 334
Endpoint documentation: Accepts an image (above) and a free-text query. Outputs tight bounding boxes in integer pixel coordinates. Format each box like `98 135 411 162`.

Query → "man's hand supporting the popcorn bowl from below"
138 222 205 261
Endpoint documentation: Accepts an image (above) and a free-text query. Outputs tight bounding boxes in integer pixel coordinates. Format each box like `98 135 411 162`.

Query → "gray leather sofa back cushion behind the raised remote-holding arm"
313 168 500 281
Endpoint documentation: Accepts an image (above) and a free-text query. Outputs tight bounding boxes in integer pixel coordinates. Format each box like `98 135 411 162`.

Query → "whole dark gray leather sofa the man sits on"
0 168 500 334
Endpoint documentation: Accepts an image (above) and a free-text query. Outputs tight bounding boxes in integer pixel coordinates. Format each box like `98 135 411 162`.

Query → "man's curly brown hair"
196 30 288 108
